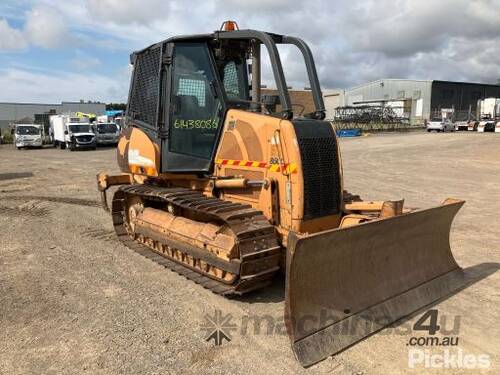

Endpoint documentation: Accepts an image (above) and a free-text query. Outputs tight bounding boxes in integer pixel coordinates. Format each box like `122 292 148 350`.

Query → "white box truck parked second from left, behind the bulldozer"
50 114 96 151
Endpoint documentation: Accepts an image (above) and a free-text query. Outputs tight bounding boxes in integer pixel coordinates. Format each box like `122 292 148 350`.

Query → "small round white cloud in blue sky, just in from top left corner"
24 5 68 48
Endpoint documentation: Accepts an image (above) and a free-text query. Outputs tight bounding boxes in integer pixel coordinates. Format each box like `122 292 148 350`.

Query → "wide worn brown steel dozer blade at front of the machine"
285 199 464 367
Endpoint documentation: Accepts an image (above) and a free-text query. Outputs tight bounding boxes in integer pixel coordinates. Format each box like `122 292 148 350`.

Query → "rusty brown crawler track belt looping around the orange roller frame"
111 184 280 296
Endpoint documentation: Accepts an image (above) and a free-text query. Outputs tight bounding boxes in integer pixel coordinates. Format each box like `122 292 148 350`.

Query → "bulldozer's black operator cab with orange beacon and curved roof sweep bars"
126 21 325 173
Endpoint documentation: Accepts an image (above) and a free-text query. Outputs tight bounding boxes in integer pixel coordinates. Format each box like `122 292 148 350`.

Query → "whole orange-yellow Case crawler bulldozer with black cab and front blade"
97 21 464 366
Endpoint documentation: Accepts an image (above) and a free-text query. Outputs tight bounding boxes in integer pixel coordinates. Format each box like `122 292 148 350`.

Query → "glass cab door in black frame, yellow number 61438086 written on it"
161 42 224 172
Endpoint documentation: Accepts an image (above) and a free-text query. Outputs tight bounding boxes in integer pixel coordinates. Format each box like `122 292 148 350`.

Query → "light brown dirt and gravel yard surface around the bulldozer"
0 132 500 374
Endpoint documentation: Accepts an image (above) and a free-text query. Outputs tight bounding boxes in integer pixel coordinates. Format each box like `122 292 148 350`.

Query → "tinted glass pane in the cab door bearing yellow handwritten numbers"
170 43 222 159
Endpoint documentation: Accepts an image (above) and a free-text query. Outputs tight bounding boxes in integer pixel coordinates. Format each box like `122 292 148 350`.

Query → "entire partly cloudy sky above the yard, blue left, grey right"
0 0 500 102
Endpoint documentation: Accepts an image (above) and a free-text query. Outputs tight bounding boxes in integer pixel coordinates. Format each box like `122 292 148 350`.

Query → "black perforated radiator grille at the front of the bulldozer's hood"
293 120 341 220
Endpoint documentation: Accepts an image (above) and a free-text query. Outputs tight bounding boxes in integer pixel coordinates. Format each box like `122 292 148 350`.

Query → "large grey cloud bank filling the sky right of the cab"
245 0 500 88
